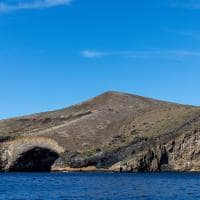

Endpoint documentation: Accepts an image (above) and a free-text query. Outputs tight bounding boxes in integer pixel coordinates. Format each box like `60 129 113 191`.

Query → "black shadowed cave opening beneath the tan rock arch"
9 147 59 172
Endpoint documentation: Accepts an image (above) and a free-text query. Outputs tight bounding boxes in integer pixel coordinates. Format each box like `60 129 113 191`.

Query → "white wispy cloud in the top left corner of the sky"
0 0 72 12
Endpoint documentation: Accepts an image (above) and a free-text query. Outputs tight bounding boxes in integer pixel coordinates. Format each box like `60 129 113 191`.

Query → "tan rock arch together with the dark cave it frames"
4 137 64 172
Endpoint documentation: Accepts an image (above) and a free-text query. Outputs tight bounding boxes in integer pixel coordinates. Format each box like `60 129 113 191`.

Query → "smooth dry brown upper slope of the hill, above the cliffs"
0 92 200 154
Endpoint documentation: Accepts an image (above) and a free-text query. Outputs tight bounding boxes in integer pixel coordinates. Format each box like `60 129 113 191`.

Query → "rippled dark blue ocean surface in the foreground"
0 173 200 200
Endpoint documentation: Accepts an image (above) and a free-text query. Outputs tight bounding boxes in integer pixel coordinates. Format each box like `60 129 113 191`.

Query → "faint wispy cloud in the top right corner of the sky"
170 0 200 9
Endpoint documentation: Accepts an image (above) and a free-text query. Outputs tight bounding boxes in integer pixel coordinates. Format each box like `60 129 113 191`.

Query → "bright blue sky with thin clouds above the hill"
0 0 200 119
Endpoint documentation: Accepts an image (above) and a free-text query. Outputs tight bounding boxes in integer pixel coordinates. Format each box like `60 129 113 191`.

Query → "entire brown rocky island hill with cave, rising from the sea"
0 92 200 172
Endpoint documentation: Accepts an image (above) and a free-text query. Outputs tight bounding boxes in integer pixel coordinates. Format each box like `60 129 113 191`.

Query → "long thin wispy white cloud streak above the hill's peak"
81 49 200 60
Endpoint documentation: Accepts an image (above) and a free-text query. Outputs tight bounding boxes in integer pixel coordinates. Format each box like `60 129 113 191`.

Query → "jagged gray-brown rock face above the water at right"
110 132 200 172
